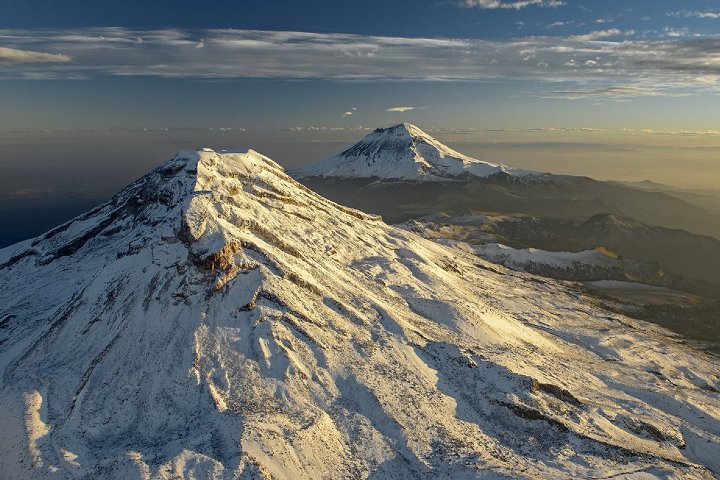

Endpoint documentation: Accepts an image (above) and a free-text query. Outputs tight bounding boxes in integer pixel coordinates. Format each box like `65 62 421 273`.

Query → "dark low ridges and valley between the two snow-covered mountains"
398 212 720 353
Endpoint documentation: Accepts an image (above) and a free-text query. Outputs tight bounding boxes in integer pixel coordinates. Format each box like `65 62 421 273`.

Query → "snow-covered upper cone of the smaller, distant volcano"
289 123 541 181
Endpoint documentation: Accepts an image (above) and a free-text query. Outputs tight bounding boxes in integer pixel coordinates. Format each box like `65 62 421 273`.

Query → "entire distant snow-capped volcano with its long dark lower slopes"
289 124 720 238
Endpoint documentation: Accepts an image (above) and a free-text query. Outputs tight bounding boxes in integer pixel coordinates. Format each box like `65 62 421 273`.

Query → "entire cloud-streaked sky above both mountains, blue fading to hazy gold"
0 0 720 233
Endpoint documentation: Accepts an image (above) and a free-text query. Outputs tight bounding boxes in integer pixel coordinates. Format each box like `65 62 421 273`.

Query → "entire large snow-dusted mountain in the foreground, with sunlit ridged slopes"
0 151 720 479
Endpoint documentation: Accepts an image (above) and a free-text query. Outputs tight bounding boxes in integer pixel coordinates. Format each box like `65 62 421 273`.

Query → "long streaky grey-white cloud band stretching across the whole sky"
0 28 720 98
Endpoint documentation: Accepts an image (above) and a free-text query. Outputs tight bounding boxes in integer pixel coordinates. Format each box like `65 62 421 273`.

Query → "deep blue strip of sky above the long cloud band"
0 0 718 38
